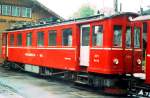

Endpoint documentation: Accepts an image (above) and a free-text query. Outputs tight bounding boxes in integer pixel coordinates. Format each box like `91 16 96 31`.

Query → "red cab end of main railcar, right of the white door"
83 14 142 75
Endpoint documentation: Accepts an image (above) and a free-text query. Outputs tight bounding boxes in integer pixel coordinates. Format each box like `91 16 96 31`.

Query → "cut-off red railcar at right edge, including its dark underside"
124 15 150 98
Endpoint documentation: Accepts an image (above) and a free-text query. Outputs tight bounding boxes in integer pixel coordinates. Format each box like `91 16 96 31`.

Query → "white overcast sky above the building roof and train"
38 0 150 19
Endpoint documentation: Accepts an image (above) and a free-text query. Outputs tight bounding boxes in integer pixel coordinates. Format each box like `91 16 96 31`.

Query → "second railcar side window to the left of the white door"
48 30 56 46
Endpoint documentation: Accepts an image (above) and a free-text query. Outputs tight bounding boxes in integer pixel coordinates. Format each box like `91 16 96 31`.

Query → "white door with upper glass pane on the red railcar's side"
80 25 90 66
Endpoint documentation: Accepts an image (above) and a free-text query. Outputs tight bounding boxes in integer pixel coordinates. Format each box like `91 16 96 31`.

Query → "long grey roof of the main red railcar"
5 12 139 32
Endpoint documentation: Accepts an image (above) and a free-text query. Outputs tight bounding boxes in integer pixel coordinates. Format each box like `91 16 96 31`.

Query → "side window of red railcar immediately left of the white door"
62 29 72 46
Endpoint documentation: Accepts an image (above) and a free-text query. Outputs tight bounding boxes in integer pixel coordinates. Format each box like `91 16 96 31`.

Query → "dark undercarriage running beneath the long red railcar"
2 61 150 97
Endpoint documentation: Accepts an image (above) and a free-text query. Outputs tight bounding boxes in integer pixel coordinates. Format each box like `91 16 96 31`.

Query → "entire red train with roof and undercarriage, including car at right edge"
2 12 150 96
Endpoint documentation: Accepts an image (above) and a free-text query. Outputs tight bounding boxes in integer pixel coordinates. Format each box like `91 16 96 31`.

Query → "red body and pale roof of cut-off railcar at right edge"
133 15 150 84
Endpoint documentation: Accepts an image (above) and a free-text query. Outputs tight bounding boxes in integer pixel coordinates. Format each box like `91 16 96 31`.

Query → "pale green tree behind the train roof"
73 5 95 18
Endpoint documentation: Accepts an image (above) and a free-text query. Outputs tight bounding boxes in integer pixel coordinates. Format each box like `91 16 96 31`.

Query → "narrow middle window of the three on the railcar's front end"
126 27 131 48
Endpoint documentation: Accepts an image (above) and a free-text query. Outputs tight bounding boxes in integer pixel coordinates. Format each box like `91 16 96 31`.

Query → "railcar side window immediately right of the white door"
92 26 103 46
